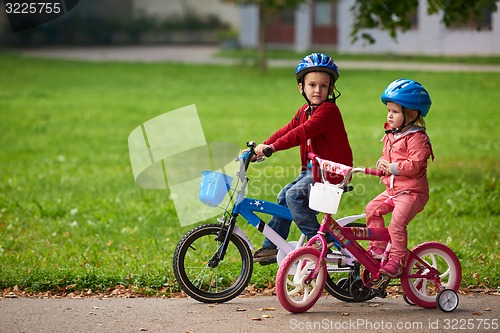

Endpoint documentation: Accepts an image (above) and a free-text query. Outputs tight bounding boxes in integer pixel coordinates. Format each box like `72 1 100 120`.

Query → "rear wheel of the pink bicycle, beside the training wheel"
401 242 462 309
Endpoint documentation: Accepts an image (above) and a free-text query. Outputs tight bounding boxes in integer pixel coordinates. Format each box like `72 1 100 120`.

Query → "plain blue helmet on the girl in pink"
380 79 432 117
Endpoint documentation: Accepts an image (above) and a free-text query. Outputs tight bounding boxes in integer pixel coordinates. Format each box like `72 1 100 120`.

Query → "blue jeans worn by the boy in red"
262 170 319 248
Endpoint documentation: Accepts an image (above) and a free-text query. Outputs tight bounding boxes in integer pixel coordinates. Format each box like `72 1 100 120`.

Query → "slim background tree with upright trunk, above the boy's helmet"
222 0 308 72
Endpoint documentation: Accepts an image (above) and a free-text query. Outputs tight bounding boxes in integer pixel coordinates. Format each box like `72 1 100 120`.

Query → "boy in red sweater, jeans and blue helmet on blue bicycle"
254 53 352 265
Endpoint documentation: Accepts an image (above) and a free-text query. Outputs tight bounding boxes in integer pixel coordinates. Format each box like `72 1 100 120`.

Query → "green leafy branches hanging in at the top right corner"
351 0 498 44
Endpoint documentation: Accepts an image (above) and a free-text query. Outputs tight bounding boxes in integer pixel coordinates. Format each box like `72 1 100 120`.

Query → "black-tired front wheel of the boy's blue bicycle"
173 224 253 303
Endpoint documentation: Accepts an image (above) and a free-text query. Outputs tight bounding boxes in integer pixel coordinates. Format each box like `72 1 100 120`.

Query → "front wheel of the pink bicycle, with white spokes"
276 246 327 313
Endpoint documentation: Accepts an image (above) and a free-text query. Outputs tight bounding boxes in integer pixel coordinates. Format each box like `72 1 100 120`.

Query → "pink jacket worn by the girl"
381 123 434 195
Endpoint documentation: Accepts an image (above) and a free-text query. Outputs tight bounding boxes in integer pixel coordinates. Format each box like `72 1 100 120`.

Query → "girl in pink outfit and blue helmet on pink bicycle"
366 79 434 277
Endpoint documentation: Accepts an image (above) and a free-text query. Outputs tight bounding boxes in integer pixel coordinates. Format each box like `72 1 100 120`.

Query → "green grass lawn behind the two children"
0 53 500 294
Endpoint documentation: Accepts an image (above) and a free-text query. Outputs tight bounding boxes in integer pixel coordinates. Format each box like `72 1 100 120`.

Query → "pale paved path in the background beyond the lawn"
16 46 500 72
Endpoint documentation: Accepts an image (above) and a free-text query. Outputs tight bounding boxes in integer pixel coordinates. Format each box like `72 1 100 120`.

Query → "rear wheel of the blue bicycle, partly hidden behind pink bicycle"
325 222 376 303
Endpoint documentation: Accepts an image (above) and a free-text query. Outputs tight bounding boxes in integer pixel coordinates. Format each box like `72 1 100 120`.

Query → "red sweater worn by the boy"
264 101 352 183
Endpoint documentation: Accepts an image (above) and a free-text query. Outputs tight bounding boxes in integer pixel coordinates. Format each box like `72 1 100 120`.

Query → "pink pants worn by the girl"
366 191 429 264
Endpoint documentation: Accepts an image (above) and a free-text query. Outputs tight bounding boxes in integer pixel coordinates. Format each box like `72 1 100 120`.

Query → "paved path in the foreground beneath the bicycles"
0 294 500 333
